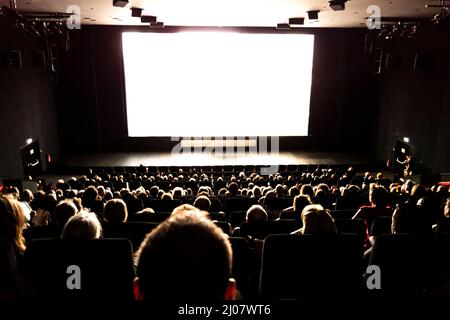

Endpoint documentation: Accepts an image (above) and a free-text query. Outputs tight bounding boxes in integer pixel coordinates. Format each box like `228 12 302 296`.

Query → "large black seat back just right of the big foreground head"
260 234 363 299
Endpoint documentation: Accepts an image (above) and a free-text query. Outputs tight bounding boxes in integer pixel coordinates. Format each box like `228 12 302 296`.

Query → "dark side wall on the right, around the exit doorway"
375 22 450 173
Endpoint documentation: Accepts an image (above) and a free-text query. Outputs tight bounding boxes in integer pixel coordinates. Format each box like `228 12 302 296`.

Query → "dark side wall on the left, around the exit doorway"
0 18 59 178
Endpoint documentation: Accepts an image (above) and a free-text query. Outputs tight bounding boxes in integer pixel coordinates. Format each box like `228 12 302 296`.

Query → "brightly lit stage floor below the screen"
59 152 377 167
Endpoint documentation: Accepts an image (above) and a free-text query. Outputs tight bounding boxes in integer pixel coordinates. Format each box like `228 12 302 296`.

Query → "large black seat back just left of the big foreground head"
25 239 134 300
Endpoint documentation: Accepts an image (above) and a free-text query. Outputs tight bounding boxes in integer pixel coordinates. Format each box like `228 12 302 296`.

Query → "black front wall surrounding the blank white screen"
58 26 377 154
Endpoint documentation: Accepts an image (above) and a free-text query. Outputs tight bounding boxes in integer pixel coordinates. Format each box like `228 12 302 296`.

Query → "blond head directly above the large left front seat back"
61 211 102 240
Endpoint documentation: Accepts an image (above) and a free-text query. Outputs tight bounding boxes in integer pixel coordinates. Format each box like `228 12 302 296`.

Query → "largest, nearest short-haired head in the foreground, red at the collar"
135 205 235 301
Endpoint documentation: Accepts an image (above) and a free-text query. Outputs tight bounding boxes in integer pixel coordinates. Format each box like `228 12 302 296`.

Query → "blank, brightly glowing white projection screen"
122 31 314 137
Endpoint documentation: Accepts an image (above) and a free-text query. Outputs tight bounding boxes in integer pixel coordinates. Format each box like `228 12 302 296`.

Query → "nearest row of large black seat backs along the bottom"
4 234 450 300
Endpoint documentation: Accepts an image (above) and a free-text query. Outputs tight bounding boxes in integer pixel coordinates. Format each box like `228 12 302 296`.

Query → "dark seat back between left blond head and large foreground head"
103 221 158 251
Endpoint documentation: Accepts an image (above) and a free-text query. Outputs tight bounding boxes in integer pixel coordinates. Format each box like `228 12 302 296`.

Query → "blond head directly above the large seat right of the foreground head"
302 204 337 235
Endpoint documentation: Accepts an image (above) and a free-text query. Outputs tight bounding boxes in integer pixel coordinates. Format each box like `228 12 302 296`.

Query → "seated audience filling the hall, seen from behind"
0 168 450 300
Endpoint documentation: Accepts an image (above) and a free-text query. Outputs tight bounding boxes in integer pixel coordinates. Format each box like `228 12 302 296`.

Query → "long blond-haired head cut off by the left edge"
0 196 26 252
